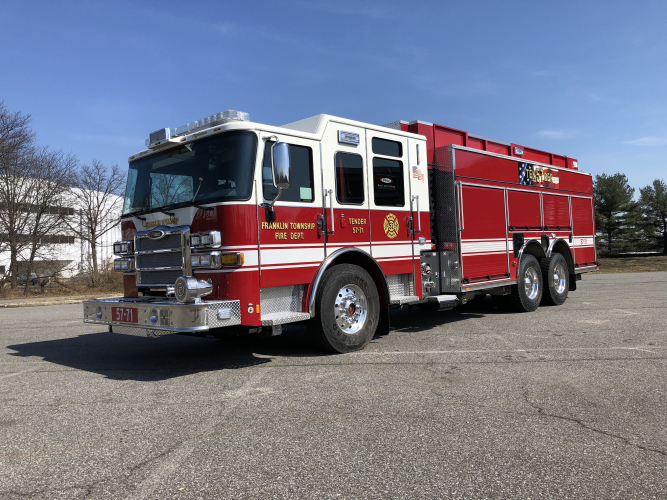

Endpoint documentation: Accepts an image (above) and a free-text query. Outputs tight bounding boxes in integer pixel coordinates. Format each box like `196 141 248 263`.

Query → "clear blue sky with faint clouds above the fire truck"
0 0 667 192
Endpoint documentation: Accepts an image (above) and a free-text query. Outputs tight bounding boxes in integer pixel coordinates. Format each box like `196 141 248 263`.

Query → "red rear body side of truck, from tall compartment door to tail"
452 148 596 285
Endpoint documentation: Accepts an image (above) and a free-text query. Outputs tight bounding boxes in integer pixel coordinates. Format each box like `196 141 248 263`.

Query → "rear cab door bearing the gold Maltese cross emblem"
366 130 415 297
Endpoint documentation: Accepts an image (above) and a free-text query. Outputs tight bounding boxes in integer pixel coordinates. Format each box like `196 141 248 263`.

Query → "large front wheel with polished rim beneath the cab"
311 264 380 353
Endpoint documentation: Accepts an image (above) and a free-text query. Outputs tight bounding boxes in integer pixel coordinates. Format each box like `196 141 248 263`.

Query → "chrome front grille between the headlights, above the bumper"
135 226 190 287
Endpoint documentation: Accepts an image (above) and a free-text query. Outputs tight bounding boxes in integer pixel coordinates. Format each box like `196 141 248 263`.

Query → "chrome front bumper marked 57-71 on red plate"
83 297 241 337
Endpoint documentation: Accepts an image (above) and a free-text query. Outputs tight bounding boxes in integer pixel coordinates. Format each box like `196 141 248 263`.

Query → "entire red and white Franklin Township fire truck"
84 111 597 352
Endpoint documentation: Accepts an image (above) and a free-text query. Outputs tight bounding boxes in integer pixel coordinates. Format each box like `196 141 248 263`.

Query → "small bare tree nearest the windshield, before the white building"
70 160 125 284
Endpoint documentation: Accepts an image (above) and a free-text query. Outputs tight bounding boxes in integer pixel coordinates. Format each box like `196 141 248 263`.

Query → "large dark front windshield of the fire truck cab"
123 132 257 215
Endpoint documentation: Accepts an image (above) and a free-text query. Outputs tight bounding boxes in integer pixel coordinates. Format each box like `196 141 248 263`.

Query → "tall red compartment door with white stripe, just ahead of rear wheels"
459 184 509 285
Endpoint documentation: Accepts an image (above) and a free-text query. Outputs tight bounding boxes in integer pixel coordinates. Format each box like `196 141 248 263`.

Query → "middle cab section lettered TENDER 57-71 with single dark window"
321 121 371 256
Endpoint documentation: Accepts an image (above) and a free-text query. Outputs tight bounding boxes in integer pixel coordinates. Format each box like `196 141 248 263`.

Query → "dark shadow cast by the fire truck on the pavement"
7 302 492 381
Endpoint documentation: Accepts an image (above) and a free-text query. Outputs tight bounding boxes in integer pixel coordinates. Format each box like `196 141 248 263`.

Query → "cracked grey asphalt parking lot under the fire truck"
0 273 667 499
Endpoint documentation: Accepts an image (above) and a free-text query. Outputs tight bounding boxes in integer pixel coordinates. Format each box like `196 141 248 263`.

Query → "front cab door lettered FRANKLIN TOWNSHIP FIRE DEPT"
257 133 324 288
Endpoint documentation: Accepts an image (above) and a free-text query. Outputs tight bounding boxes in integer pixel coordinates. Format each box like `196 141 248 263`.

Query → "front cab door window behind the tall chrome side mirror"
262 142 315 203
